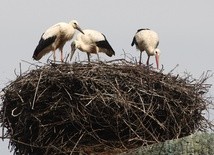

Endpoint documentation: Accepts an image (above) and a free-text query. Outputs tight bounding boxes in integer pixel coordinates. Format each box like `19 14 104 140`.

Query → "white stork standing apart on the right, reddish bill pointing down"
131 28 160 69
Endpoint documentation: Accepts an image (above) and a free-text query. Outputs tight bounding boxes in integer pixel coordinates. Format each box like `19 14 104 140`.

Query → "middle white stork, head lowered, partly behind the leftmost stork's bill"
70 29 115 62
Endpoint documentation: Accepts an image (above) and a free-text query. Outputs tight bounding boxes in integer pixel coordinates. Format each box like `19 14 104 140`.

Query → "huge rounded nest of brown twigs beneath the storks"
0 61 211 154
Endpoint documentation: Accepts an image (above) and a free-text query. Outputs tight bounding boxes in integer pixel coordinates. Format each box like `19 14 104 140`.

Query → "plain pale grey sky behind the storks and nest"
0 0 214 155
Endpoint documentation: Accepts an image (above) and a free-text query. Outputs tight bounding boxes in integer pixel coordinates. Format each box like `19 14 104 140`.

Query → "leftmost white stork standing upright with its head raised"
33 20 83 62
